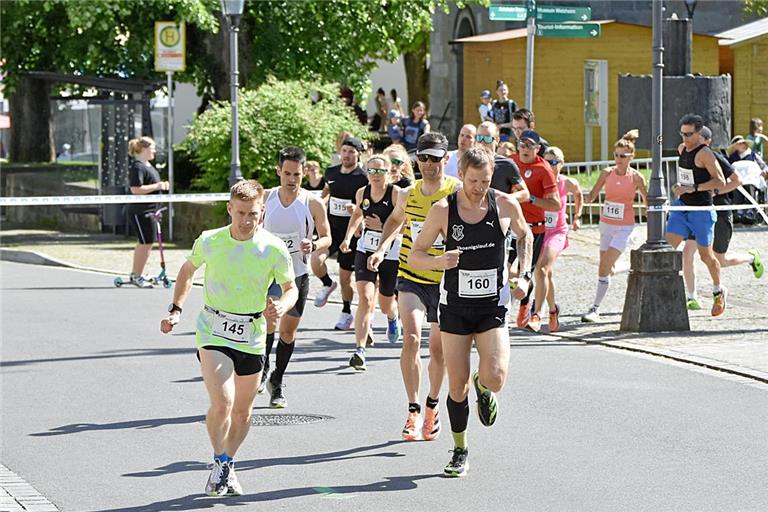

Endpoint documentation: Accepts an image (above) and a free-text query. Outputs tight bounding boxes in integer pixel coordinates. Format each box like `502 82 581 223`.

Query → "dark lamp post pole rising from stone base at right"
646 0 667 247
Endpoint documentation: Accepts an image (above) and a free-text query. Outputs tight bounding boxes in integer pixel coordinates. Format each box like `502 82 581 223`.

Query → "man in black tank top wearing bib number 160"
408 147 533 476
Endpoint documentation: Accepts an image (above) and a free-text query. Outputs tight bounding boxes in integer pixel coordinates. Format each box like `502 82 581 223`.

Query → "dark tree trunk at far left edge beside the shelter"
8 75 56 162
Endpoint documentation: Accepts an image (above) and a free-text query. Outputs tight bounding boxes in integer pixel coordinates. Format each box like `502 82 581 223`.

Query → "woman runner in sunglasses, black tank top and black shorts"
339 155 400 370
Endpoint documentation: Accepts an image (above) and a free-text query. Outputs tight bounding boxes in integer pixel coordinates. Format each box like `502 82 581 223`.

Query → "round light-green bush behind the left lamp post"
181 77 367 192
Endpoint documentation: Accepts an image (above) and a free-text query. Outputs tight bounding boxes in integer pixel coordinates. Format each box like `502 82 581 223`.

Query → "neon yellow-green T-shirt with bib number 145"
187 226 294 354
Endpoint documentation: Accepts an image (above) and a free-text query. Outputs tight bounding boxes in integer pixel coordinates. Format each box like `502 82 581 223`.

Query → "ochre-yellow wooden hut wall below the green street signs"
464 22 719 162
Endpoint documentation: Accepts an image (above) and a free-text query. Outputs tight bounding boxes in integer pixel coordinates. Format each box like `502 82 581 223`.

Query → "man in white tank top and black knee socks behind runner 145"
259 146 331 409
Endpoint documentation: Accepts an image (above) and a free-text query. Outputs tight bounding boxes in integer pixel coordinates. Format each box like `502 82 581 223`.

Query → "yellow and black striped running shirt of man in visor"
398 176 459 284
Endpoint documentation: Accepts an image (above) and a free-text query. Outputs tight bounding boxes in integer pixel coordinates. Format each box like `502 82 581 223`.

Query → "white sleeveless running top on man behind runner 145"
264 187 315 277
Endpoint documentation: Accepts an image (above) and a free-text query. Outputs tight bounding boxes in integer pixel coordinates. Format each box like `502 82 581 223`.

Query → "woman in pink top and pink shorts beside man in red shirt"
529 146 583 332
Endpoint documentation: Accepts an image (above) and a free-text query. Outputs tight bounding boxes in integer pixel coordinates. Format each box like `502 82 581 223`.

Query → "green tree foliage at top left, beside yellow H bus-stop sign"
0 0 218 91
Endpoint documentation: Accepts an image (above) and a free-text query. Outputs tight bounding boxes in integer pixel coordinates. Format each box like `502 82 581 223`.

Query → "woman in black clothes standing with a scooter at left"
128 137 169 288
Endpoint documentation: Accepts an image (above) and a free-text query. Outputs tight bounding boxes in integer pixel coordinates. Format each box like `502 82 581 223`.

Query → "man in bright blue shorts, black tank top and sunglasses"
667 114 728 316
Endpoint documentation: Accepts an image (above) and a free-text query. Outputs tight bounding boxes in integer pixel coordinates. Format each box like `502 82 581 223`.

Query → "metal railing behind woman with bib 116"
560 156 677 224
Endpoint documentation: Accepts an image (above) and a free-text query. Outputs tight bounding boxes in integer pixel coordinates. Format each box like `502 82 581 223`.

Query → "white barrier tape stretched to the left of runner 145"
0 193 229 206
